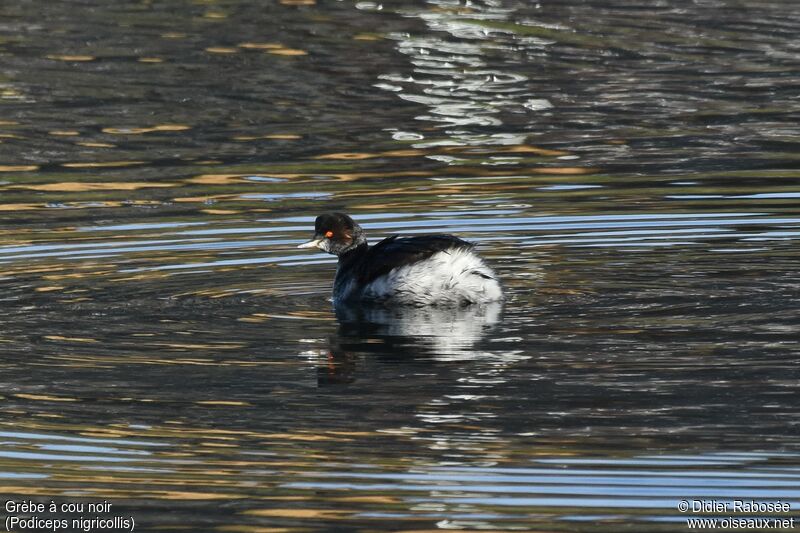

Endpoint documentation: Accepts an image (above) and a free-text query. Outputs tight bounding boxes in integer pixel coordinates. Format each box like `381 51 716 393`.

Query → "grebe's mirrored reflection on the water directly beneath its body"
317 302 503 385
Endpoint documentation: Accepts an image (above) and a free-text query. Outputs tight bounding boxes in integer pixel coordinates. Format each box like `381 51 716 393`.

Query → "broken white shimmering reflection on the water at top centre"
376 1 553 130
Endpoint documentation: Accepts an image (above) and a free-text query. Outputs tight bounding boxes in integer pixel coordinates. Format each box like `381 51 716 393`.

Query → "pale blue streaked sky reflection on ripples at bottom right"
285 452 800 529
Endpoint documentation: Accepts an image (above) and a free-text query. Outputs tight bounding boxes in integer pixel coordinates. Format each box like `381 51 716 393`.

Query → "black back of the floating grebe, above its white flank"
351 235 474 284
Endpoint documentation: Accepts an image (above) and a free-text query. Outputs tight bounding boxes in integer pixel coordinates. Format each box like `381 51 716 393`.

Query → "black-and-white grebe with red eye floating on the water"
298 213 503 306
